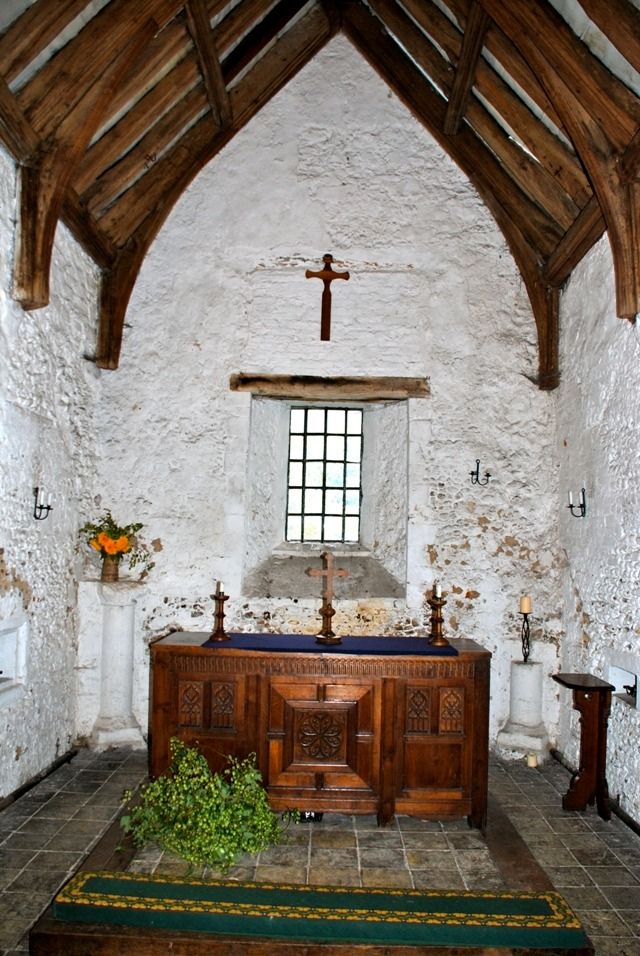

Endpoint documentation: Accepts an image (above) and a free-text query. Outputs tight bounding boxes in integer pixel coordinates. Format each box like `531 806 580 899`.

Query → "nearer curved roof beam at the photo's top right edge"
481 0 640 319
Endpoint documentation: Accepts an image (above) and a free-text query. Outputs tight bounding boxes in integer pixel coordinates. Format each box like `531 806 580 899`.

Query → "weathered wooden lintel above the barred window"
229 372 431 402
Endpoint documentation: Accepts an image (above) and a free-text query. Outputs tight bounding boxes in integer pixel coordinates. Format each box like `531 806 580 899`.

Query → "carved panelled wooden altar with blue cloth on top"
150 632 491 828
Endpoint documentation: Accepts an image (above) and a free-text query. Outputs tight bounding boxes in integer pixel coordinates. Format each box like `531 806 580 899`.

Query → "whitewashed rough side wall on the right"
557 237 640 820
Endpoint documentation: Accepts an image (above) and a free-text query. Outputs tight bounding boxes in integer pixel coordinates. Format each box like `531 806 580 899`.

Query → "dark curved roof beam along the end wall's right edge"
344 3 559 389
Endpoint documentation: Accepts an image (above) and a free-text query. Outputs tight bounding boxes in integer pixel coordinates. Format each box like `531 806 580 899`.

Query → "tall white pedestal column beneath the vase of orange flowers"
91 582 146 749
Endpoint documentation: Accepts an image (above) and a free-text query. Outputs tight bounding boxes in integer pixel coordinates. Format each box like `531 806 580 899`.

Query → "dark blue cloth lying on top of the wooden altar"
202 632 458 657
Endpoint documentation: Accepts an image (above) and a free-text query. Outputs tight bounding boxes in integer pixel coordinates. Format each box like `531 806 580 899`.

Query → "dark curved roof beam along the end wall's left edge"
96 2 332 369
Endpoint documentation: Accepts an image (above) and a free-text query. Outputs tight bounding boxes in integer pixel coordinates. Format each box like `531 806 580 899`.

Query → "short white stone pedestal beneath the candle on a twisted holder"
496 661 549 766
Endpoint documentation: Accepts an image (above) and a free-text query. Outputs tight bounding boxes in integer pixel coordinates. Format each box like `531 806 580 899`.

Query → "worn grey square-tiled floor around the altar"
0 750 640 956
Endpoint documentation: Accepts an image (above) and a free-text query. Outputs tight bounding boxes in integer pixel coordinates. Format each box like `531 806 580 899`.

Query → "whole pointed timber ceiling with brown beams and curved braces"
0 0 640 389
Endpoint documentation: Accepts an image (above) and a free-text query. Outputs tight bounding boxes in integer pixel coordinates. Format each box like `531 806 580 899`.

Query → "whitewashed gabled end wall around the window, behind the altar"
86 38 563 737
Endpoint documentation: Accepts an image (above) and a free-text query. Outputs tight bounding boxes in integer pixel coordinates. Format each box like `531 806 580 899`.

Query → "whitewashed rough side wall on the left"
0 144 98 797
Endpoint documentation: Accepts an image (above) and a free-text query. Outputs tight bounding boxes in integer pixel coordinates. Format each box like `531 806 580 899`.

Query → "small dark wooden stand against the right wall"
553 674 615 820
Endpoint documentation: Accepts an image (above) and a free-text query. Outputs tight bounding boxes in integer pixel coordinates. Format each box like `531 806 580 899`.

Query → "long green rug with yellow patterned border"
52 873 591 952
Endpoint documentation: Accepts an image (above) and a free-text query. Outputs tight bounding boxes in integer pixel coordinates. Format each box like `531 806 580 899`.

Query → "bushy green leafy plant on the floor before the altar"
120 737 296 870
